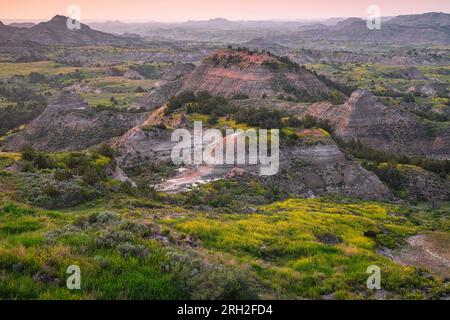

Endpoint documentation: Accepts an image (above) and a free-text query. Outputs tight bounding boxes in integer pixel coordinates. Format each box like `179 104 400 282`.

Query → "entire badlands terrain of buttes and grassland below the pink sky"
0 13 450 299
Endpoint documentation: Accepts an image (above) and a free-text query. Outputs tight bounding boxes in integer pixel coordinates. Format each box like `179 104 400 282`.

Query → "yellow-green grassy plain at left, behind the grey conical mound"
0 61 161 111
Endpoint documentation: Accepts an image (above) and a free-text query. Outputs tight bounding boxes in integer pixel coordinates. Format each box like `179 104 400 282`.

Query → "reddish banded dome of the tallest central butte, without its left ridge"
182 49 329 100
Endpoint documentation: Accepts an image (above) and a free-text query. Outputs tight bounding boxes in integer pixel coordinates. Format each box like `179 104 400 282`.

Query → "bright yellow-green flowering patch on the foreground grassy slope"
171 199 450 299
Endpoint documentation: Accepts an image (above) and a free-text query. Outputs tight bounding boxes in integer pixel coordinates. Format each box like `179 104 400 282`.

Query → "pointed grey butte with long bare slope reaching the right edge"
303 90 450 159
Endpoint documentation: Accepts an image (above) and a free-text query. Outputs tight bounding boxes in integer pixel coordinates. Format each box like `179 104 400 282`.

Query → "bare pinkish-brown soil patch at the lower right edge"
393 232 450 277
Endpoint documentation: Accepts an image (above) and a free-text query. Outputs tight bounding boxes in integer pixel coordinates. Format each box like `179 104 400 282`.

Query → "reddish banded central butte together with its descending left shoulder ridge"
132 49 330 110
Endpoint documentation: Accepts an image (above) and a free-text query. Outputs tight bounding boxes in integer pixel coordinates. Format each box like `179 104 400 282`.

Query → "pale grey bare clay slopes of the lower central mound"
115 107 390 199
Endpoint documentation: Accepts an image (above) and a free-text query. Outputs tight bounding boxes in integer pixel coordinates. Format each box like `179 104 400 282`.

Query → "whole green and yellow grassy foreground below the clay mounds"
0 150 450 299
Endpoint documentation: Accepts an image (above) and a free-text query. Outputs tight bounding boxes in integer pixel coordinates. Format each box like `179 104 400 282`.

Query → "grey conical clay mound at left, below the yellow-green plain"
2 92 146 151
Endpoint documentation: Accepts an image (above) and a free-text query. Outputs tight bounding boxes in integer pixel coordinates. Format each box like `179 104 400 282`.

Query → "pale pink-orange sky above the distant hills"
0 0 450 21
